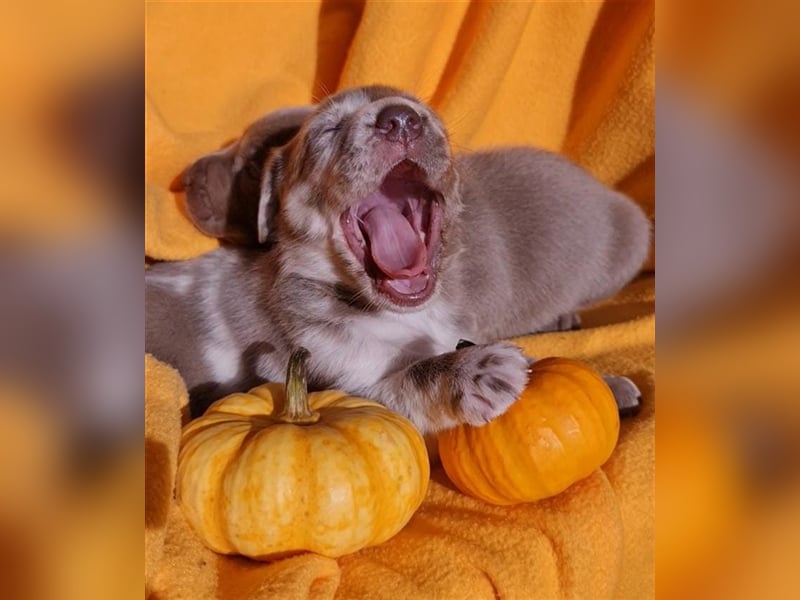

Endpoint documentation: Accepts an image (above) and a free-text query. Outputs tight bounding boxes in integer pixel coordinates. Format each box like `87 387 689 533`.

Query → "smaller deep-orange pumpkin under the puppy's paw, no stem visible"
438 358 619 505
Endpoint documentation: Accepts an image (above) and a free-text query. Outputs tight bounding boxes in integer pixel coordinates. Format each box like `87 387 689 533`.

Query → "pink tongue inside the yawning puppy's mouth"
362 205 427 279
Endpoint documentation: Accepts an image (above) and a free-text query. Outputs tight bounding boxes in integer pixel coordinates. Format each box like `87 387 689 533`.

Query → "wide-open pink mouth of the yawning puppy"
341 160 442 306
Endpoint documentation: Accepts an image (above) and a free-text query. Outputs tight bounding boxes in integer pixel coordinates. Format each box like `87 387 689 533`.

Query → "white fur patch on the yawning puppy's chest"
310 310 463 389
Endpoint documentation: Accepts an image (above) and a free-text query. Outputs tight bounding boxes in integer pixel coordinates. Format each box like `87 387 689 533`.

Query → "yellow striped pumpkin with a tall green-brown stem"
177 349 430 559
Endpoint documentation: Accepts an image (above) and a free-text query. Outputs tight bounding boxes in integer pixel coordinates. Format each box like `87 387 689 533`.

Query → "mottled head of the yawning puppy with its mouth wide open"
185 86 461 311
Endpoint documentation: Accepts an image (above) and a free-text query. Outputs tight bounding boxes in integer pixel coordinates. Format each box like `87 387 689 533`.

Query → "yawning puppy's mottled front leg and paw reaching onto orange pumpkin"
367 343 530 433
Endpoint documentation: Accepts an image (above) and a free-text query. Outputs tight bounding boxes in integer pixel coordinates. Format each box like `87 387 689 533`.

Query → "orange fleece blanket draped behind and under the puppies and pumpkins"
145 1 654 600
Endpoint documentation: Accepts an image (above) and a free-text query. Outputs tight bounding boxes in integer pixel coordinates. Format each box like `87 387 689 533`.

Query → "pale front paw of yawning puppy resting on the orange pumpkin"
453 343 530 426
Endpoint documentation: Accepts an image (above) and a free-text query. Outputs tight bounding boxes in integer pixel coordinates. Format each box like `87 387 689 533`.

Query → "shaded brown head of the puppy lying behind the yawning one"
183 106 314 246
